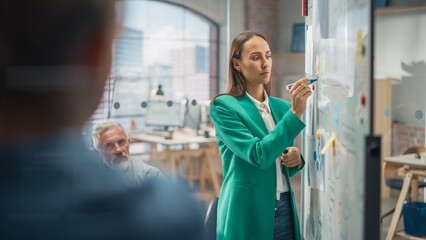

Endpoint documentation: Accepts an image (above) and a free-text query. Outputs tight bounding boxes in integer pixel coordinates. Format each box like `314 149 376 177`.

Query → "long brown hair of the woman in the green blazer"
210 31 271 104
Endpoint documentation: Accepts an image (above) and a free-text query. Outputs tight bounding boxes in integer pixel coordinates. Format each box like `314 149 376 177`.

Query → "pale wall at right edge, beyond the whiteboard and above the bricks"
374 10 426 126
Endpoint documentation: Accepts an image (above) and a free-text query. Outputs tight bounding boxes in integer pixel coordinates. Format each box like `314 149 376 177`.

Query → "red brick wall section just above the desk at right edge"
392 123 425 156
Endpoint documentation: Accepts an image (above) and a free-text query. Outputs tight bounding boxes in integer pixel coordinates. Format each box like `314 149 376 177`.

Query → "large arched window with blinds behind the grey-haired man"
87 0 218 142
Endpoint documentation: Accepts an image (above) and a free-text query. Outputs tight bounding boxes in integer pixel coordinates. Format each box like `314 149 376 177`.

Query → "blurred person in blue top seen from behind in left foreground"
0 0 202 240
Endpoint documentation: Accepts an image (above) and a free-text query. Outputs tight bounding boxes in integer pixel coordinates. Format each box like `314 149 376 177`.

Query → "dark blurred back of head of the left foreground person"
0 0 116 141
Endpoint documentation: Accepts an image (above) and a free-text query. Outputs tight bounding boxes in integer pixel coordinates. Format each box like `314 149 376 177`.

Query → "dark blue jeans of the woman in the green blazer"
274 192 294 240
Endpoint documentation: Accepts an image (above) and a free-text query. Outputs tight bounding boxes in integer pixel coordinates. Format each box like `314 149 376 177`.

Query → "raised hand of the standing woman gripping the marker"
290 78 311 118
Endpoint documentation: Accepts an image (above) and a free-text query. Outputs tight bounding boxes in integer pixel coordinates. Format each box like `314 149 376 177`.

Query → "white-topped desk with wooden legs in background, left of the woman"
128 131 222 197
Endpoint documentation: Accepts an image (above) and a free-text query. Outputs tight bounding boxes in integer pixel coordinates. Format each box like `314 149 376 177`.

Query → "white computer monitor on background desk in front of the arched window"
145 100 185 127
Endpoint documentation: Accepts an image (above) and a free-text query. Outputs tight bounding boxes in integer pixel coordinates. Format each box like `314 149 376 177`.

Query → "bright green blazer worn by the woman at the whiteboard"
210 94 305 240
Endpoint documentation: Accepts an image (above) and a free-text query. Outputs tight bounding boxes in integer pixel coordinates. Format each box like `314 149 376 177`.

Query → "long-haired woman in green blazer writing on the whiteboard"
210 32 311 240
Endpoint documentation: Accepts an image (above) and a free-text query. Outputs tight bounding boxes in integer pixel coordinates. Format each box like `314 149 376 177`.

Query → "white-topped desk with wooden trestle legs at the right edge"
384 154 426 240
